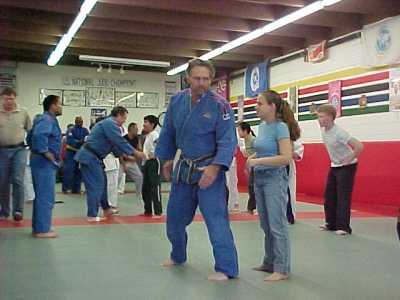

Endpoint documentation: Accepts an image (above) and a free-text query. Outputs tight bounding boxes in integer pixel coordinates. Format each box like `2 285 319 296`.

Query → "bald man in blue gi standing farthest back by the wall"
62 116 89 194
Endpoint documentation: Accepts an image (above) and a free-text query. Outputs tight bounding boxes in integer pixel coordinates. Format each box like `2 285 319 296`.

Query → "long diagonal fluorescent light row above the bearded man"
167 0 342 75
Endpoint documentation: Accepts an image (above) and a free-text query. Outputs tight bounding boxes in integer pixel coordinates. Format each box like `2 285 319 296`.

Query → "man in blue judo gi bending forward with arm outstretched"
74 106 144 222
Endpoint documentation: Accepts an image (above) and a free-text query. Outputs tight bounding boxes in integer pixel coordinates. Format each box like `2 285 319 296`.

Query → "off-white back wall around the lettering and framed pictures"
17 63 177 131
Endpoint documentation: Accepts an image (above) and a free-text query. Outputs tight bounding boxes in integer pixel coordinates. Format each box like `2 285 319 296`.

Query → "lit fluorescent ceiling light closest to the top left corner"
47 0 97 67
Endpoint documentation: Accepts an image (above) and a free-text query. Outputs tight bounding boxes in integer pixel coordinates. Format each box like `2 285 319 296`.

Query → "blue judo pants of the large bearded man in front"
167 172 239 278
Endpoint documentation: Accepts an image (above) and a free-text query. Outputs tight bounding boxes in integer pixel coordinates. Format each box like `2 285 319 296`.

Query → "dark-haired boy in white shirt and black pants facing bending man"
142 115 162 218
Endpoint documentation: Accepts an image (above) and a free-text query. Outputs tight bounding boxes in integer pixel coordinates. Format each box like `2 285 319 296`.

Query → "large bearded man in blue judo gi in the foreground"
155 59 239 281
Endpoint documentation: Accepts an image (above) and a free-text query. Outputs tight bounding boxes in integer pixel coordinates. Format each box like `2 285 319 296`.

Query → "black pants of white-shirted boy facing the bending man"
142 159 162 216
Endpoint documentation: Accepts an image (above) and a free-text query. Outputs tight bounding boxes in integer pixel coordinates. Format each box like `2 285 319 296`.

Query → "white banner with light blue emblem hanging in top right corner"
361 16 400 66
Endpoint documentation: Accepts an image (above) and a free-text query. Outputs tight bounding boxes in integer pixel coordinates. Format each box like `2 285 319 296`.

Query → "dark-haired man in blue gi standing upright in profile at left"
27 95 62 238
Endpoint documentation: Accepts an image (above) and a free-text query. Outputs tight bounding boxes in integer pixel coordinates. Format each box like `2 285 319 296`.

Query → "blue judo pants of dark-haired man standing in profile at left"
30 154 57 233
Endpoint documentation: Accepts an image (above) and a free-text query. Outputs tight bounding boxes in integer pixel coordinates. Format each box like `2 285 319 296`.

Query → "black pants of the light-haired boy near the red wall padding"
324 164 357 233
